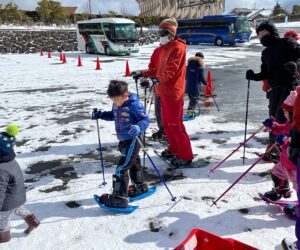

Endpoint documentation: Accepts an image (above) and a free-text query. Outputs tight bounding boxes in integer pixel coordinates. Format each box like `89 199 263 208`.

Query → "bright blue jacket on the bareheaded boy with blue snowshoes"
99 93 149 141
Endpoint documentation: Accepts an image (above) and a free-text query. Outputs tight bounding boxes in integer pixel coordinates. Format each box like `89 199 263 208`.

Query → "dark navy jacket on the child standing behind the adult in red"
185 56 207 96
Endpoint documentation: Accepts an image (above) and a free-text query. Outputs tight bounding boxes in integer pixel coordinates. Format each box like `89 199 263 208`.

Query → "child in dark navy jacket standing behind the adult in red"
185 52 207 118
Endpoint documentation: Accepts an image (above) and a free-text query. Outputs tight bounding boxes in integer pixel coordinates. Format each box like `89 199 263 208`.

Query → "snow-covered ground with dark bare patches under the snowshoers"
0 41 295 250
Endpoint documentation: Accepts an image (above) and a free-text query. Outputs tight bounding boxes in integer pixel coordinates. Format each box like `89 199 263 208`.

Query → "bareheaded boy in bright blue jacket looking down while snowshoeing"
92 80 149 208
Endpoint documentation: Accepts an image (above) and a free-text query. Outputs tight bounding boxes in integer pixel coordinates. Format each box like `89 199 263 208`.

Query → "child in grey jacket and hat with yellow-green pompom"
0 124 40 243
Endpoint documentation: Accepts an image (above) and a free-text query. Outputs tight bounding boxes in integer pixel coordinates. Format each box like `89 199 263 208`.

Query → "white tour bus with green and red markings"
77 18 139 55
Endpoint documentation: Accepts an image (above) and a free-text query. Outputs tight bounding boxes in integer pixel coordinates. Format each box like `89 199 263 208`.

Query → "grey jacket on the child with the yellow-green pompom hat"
0 159 26 212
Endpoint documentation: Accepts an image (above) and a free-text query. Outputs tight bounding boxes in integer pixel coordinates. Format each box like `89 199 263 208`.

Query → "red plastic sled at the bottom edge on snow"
175 228 258 250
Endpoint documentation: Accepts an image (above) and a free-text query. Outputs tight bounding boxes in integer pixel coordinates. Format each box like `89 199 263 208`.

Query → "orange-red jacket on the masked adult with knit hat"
155 37 186 100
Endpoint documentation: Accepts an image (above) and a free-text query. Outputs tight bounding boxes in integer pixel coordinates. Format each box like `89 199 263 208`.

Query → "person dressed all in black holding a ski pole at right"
246 21 300 145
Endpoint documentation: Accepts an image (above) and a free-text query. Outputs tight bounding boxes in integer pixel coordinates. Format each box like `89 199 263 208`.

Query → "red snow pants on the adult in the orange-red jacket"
160 96 194 161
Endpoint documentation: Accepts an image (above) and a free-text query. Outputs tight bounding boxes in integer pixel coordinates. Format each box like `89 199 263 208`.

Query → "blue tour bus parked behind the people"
177 15 251 46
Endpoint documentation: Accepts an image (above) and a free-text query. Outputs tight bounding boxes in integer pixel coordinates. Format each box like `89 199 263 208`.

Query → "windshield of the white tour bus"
114 23 138 41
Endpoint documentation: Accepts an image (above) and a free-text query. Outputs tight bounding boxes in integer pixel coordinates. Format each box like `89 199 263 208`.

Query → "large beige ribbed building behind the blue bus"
136 0 225 18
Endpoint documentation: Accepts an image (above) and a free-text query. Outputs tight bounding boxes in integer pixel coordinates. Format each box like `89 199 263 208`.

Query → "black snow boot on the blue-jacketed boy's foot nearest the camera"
99 173 129 208
